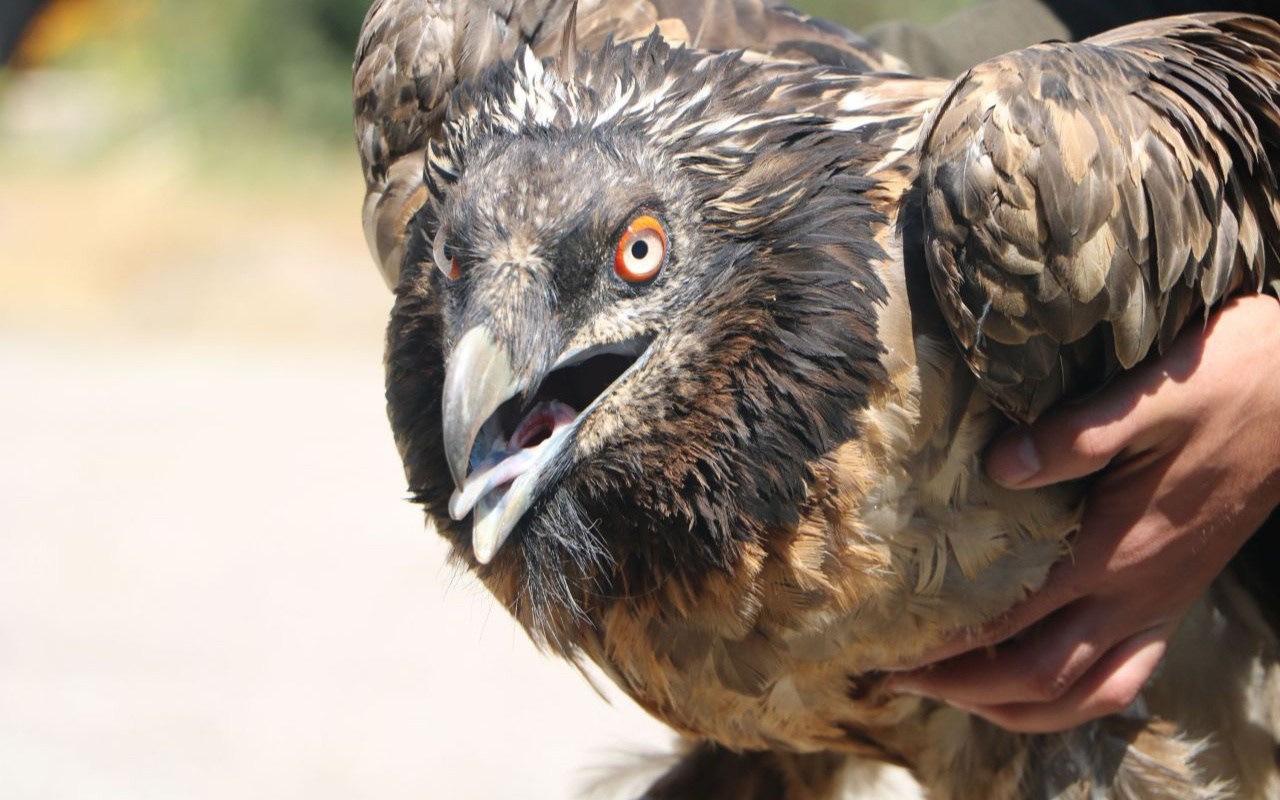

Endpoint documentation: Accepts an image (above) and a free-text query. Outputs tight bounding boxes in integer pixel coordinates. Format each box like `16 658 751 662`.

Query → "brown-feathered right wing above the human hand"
919 14 1280 421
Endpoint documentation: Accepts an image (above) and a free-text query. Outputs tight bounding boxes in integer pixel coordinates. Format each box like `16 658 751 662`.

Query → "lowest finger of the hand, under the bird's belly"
957 625 1176 733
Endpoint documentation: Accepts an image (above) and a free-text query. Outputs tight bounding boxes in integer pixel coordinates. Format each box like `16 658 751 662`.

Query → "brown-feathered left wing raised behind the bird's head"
353 0 902 287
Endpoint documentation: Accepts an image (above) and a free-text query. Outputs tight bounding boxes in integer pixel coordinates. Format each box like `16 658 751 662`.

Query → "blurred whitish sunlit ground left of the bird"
0 335 691 800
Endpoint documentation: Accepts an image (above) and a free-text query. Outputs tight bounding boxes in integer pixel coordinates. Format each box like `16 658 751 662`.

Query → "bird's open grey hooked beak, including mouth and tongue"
443 325 652 563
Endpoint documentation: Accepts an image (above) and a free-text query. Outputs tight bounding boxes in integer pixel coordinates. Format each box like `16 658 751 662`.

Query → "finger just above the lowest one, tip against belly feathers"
890 602 1115 705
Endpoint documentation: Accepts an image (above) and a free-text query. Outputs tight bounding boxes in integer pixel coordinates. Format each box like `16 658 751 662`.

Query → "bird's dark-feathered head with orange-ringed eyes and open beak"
388 37 883 649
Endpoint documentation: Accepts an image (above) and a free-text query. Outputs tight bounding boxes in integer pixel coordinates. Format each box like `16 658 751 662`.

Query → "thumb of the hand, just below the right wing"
984 367 1164 489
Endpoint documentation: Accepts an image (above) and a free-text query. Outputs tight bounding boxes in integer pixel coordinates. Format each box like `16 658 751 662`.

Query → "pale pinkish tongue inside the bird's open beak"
449 399 577 524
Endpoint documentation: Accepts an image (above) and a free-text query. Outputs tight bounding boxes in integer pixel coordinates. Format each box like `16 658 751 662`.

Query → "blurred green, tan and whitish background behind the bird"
0 0 968 800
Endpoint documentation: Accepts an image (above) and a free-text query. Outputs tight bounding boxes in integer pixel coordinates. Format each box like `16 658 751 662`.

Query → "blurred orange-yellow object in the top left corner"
13 0 152 67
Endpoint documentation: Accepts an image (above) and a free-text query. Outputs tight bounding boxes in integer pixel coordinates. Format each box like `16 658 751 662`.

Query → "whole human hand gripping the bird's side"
890 296 1280 732
